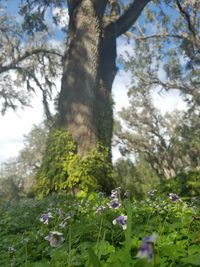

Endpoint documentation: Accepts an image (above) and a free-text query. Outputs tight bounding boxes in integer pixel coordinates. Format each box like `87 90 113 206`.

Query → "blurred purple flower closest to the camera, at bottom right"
137 233 158 261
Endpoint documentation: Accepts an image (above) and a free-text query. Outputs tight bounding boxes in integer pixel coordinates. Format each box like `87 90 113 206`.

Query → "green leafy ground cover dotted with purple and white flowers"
0 189 200 267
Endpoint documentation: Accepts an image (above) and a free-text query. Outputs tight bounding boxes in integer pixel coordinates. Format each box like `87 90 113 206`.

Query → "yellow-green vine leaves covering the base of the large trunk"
36 130 113 197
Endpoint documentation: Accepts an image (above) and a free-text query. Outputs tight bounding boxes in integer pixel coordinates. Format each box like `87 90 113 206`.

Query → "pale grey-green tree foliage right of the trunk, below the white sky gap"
115 87 200 180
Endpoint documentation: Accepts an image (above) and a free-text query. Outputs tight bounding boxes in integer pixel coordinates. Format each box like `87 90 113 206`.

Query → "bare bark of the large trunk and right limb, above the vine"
58 0 149 157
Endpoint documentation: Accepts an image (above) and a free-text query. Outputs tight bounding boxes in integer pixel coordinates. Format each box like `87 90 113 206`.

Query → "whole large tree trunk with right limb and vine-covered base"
38 0 149 195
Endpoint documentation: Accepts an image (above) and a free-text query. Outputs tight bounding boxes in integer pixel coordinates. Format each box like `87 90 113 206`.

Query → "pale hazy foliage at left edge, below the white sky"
0 123 48 199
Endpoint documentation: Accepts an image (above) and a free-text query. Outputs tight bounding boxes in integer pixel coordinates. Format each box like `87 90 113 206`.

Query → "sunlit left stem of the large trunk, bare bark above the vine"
58 1 101 155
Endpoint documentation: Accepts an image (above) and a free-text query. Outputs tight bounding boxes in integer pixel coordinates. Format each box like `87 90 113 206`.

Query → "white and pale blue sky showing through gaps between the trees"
0 1 188 162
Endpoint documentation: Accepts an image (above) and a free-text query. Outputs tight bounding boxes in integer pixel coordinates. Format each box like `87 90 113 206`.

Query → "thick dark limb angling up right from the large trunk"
108 0 151 37
